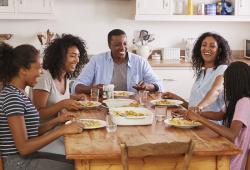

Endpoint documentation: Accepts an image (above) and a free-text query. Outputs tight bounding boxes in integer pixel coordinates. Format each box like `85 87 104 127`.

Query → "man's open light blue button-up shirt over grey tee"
71 51 163 93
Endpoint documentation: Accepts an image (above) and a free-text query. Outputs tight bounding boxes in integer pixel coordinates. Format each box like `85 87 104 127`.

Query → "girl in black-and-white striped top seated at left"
0 43 83 170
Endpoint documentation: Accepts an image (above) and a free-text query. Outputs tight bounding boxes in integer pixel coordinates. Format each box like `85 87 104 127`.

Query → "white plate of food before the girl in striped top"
65 119 106 129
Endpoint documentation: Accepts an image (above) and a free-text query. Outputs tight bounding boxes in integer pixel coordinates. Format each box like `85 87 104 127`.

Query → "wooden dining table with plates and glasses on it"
64 94 241 170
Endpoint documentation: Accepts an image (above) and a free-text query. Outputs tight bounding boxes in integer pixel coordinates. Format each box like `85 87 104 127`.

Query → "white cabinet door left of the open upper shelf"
136 0 170 15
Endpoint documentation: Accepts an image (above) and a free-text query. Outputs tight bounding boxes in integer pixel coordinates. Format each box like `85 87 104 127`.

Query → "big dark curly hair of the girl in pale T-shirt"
43 34 88 79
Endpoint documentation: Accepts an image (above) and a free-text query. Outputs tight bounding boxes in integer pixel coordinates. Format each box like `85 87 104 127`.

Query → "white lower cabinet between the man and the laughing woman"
153 67 195 100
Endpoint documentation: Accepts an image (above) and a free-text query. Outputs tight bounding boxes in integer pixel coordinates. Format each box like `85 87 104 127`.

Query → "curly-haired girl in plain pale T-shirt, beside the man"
31 34 88 154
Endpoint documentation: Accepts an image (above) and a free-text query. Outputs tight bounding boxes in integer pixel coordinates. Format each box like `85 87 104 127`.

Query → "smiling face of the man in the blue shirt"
109 35 127 58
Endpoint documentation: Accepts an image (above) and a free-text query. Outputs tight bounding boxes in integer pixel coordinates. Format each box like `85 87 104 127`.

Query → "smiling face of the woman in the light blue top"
201 36 218 67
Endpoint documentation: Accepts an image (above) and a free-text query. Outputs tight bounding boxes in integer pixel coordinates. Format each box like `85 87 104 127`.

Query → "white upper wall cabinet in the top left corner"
0 0 54 19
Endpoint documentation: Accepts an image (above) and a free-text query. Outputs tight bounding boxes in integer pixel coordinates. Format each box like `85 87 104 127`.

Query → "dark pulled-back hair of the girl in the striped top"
0 43 40 86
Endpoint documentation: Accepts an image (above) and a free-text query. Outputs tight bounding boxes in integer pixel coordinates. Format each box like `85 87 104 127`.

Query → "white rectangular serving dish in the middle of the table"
109 107 154 125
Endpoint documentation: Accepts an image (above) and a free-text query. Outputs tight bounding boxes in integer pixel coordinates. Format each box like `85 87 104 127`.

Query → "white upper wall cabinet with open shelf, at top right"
135 0 250 22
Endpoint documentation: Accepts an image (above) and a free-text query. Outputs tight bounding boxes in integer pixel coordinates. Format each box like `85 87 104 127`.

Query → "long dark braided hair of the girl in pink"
223 61 250 127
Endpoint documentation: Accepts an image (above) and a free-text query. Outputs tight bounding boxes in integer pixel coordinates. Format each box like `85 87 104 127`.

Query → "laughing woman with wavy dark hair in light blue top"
163 32 231 111
